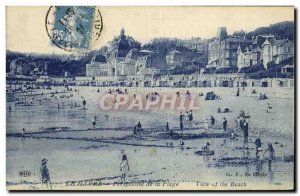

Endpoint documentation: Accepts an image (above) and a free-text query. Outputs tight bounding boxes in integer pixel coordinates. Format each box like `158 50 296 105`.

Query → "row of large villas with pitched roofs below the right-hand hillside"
208 27 294 70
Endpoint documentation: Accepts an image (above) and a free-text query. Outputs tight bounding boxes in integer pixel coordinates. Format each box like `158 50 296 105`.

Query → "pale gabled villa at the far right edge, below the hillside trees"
262 37 294 69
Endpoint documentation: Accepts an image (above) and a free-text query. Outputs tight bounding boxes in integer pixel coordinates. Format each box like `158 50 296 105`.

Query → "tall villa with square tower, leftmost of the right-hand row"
207 27 251 68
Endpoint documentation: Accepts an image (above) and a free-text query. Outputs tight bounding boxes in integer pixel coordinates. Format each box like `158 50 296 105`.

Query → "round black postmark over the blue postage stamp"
45 6 103 52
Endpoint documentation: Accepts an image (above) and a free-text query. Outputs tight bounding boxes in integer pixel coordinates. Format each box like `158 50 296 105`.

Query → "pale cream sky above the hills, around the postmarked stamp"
6 6 294 54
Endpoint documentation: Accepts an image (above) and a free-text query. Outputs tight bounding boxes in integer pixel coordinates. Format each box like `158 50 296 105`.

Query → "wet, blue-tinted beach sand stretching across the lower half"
7 87 294 189
